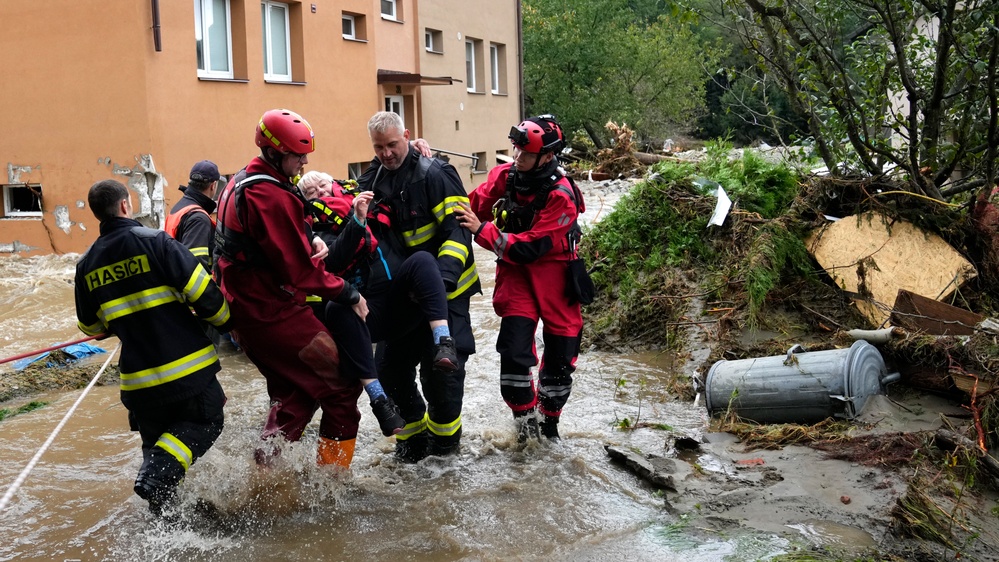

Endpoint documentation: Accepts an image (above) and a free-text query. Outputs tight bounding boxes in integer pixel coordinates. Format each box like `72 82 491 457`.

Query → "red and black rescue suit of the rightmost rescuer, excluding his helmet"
469 164 583 423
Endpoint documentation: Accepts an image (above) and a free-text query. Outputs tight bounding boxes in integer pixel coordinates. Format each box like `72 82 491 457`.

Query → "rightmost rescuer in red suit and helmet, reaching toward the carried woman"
456 115 583 441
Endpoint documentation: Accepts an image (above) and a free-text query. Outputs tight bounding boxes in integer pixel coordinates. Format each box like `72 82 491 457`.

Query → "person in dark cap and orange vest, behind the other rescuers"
163 160 220 271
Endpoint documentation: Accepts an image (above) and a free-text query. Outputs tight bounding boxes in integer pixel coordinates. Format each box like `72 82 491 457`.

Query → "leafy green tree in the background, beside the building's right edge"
524 0 723 148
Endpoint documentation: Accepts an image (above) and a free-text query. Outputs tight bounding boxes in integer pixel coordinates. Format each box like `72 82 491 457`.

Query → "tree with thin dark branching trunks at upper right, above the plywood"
720 0 999 199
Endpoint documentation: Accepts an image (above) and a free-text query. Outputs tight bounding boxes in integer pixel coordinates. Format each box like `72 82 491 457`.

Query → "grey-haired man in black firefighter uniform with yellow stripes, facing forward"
357 111 481 462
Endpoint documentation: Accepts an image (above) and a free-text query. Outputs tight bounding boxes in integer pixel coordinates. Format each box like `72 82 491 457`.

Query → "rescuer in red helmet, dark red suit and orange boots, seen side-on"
216 109 402 468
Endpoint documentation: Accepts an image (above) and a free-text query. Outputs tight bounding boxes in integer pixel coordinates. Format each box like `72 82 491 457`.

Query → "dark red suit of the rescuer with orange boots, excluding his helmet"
216 157 361 441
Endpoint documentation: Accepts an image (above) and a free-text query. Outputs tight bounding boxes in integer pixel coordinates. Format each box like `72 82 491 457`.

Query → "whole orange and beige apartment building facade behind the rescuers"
0 0 519 255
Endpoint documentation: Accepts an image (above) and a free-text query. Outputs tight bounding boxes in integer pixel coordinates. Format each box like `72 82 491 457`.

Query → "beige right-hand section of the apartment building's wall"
418 0 521 190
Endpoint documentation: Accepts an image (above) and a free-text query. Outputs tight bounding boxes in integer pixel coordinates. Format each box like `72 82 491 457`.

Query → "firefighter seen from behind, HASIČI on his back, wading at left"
76 180 230 515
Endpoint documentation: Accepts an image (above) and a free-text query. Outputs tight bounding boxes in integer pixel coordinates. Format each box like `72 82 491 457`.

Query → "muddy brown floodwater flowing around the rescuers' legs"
0 244 787 562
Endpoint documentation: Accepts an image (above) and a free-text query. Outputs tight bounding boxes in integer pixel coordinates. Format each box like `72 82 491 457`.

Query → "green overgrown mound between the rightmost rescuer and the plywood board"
581 150 813 348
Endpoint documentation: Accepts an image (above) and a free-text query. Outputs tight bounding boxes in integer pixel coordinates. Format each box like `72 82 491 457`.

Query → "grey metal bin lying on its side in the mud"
704 340 889 423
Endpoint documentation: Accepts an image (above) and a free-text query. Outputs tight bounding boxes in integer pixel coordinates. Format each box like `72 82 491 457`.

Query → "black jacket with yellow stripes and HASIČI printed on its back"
76 218 231 409
